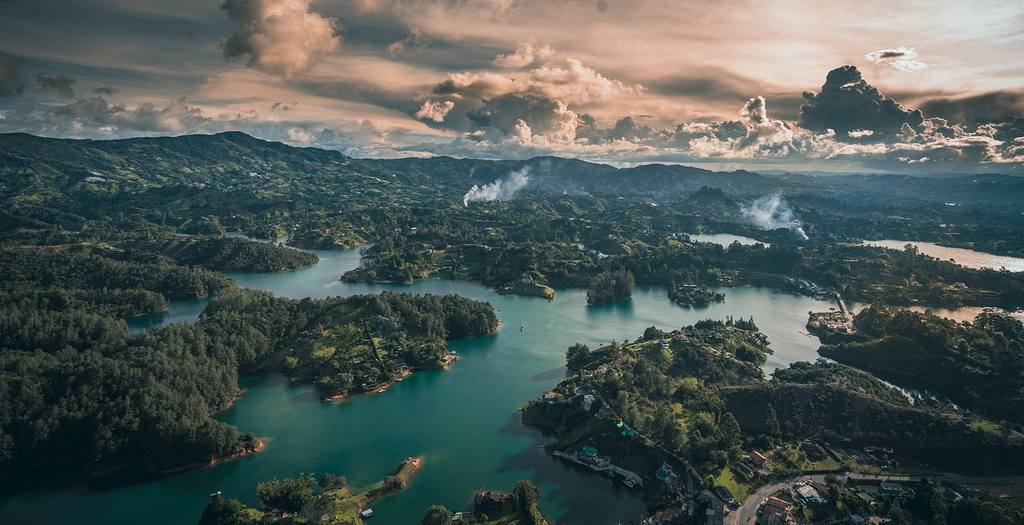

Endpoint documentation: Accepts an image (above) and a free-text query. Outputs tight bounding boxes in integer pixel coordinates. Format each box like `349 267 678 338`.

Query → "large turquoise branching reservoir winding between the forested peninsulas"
0 243 835 525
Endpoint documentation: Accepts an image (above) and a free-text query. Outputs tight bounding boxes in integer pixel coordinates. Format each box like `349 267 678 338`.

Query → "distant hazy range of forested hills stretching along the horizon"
0 132 1024 211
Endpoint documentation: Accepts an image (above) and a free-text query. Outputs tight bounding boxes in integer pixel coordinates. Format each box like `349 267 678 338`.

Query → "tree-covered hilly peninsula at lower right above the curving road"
522 319 1024 508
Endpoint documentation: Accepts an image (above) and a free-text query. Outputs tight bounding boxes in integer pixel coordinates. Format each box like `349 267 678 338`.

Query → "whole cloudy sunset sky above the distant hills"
0 0 1024 174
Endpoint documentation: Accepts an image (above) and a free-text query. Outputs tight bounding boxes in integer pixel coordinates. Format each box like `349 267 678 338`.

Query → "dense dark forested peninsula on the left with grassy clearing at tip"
0 243 498 473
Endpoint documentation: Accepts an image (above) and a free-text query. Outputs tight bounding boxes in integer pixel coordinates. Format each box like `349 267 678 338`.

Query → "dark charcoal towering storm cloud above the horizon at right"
799 65 924 142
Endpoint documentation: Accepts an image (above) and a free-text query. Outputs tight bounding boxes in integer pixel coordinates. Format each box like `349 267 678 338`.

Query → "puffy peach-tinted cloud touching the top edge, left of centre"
220 0 341 78
